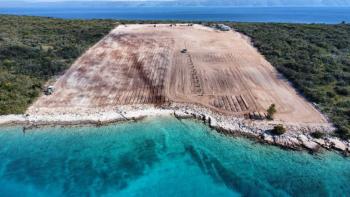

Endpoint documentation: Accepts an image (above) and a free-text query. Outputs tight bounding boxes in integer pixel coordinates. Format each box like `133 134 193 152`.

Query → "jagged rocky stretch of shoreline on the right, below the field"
171 103 350 156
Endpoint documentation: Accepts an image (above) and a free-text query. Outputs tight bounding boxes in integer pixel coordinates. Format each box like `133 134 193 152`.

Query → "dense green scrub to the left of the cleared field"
0 15 115 115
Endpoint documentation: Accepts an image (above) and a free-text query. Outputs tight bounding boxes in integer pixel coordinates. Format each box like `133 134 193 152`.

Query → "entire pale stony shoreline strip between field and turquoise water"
0 103 350 155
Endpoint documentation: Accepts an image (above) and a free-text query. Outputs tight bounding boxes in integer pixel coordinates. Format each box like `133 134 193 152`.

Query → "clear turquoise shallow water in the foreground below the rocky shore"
0 118 350 197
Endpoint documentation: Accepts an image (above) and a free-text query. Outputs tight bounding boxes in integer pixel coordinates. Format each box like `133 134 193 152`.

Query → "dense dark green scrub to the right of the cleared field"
229 23 350 139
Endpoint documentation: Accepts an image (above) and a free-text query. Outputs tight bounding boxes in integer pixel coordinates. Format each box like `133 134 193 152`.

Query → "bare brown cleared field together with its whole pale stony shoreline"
0 23 350 152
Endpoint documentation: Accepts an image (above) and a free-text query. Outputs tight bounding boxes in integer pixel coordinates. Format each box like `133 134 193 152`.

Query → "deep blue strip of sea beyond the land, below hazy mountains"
0 6 350 23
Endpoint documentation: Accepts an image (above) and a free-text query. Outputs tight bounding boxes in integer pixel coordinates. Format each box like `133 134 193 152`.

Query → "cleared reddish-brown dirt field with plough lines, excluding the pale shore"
28 25 326 123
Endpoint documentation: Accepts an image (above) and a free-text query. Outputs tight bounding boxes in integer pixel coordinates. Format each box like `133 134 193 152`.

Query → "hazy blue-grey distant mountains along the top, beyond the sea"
0 0 350 7
